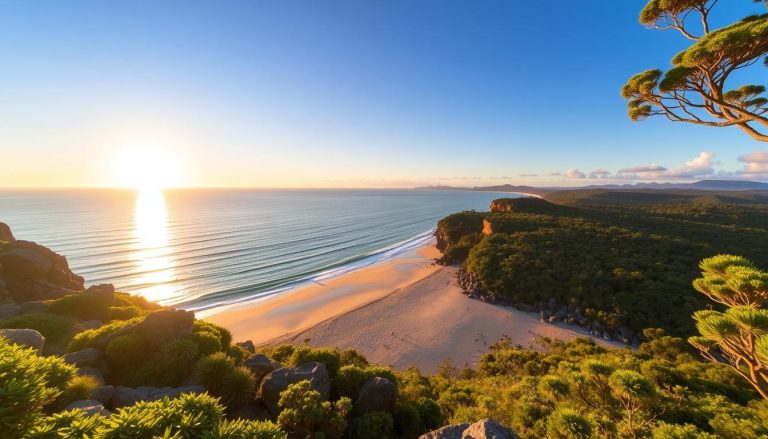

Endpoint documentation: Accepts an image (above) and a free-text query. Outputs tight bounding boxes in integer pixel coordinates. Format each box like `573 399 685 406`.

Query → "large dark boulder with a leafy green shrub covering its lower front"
260 363 331 416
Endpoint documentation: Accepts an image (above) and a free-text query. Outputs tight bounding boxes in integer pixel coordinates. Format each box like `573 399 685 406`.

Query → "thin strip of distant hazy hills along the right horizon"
416 180 768 195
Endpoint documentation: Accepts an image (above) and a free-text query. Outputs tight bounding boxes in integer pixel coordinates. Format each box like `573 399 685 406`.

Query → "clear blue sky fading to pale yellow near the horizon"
0 0 767 187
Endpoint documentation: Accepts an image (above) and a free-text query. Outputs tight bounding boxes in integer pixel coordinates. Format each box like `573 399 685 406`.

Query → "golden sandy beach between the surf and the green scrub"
206 242 624 372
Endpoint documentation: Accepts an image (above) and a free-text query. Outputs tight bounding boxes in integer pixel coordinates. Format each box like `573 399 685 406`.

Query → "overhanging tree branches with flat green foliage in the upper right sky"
621 0 768 142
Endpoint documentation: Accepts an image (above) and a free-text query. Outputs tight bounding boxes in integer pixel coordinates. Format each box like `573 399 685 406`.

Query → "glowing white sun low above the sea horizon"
114 146 182 190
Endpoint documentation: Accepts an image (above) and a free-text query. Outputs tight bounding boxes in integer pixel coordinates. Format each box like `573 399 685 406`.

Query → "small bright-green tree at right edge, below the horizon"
688 255 768 399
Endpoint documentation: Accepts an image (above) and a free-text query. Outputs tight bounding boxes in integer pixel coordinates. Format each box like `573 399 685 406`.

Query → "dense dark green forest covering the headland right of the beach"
438 194 768 335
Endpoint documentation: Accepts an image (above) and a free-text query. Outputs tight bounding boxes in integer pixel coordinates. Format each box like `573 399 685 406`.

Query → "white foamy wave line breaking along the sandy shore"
187 229 435 318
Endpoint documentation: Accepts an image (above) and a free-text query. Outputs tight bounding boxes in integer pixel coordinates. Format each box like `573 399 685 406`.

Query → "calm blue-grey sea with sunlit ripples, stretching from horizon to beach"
0 190 515 309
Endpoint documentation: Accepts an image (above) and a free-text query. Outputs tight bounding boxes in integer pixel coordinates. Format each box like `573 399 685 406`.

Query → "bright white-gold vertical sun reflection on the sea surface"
133 189 177 302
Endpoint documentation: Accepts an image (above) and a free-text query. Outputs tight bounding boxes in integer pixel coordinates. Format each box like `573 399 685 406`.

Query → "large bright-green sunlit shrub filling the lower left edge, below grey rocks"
0 337 75 438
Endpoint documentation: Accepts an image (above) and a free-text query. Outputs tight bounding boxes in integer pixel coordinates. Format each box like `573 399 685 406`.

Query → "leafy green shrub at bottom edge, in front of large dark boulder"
277 380 352 439
